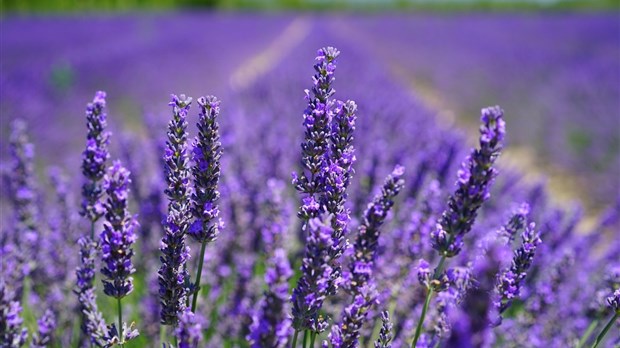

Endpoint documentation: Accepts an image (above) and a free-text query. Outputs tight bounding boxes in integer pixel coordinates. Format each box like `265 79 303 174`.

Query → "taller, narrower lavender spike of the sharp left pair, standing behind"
81 91 110 223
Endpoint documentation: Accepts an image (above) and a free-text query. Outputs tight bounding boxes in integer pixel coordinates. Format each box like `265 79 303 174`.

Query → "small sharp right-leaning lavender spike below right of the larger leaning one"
495 222 541 325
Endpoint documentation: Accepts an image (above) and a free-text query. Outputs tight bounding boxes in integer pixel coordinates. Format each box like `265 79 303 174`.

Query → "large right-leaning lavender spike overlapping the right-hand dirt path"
431 106 506 257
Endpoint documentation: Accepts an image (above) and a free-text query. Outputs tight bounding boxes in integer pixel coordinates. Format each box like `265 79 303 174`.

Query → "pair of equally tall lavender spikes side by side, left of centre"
159 95 223 346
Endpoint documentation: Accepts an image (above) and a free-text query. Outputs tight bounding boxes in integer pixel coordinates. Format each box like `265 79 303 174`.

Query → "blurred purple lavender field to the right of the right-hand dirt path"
343 13 620 207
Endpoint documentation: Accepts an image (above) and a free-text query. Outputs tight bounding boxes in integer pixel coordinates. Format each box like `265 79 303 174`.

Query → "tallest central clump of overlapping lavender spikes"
292 47 357 346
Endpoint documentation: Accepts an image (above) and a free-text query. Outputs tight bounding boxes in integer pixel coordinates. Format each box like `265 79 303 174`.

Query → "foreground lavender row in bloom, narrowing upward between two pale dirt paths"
0 19 620 348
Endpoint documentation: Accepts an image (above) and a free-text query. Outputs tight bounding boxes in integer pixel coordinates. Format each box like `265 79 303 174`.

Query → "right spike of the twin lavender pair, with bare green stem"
188 96 223 312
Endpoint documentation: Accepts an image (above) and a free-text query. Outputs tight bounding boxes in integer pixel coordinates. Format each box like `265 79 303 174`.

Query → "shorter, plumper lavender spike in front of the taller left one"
101 161 138 299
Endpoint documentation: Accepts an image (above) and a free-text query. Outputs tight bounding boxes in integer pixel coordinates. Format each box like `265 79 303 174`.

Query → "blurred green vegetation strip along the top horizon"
0 0 620 15
